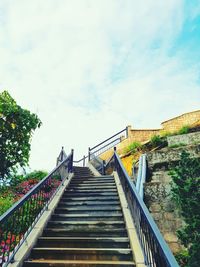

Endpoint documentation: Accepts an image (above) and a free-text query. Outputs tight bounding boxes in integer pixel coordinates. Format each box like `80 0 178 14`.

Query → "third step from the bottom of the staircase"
37 237 130 248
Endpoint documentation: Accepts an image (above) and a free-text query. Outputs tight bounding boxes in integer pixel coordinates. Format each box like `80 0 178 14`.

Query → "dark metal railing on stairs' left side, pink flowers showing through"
0 150 73 267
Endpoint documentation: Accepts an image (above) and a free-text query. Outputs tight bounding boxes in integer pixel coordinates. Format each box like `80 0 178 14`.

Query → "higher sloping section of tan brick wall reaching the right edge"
161 110 200 132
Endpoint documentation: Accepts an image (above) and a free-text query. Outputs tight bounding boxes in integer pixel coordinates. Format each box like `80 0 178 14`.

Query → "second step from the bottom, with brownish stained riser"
30 247 132 261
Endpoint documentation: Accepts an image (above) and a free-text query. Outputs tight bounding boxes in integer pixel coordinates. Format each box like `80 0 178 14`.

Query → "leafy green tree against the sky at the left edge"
0 91 41 182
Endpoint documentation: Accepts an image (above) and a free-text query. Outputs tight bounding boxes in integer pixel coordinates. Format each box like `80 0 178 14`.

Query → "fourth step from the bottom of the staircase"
43 227 127 237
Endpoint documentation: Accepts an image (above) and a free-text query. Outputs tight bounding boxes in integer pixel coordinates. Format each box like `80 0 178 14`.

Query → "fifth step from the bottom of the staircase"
47 219 125 231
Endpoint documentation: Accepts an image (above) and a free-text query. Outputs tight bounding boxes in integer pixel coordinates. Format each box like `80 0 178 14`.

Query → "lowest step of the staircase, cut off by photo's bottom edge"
23 260 136 267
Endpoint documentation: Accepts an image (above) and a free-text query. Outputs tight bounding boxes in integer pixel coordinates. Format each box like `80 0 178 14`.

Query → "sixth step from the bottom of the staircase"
51 214 123 221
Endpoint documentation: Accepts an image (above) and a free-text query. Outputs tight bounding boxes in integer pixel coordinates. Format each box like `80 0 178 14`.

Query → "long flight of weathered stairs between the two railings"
23 167 135 267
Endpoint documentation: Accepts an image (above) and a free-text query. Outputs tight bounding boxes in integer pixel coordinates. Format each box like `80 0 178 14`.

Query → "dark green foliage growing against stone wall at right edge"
171 151 200 267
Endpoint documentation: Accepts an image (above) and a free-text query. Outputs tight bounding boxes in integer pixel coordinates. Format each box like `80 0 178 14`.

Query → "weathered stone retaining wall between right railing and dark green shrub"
144 144 200 253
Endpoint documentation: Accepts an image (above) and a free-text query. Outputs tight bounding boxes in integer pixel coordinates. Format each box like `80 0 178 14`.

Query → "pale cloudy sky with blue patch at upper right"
0 0 200 170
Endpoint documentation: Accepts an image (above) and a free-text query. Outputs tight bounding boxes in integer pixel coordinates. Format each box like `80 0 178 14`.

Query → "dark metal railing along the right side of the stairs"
114 152 179 267
